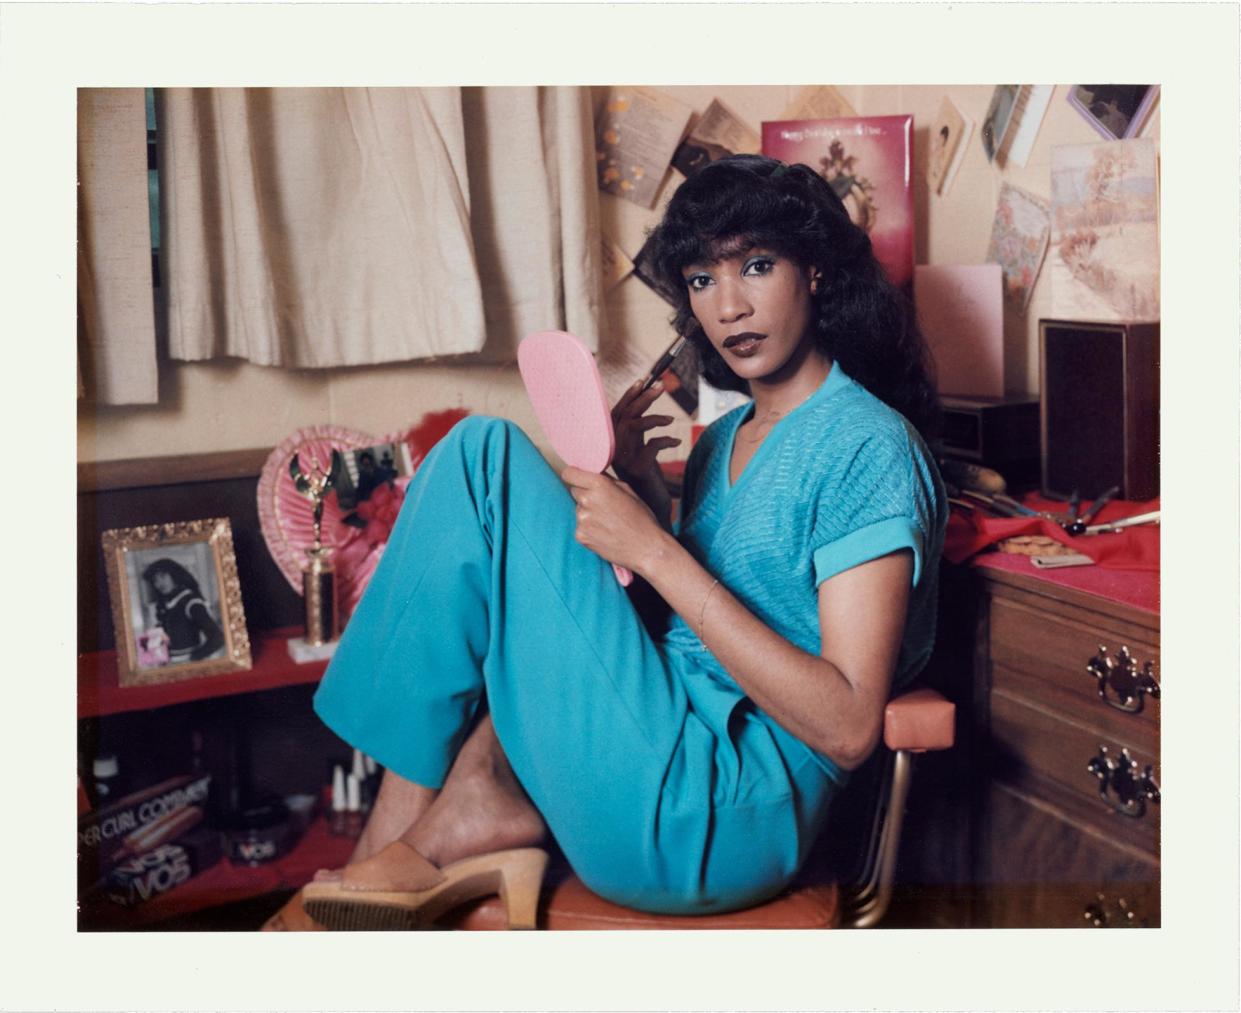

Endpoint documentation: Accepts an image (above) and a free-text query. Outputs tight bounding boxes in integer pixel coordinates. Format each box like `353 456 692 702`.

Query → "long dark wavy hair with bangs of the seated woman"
648 155 939 438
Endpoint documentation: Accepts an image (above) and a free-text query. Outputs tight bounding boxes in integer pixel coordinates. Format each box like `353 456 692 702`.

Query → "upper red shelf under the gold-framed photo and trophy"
78 628 328 718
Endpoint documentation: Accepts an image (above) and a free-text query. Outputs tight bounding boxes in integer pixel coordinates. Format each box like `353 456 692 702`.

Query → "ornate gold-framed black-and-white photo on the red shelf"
103 518 251 687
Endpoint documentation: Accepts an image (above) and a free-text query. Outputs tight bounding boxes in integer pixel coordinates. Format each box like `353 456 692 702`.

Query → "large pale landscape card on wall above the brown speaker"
1047 140 1159 322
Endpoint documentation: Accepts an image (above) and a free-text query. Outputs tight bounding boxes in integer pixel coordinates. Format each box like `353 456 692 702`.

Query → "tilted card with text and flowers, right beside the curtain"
594 87 692 209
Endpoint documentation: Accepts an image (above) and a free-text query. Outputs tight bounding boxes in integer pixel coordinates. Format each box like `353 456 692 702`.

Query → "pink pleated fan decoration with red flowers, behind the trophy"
258 408 468 619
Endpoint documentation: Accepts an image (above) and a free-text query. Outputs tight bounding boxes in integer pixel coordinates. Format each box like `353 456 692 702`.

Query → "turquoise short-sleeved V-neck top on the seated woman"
664 365 947 774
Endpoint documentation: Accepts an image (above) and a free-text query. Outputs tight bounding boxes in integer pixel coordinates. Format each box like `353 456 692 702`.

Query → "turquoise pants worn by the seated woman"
315 417 834 914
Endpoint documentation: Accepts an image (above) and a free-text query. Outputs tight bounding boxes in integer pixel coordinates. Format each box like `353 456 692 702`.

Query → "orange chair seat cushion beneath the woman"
439 867 840 931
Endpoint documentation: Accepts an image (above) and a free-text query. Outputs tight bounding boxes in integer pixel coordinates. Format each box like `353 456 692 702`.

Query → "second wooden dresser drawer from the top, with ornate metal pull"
990 688 1159 857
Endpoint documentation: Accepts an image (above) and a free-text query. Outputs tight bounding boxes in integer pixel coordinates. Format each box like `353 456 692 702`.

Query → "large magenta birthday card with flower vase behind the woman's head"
763 115 913 286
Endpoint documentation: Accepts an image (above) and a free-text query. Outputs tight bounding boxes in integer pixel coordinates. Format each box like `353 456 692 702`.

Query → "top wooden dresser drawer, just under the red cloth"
989 597 1160 740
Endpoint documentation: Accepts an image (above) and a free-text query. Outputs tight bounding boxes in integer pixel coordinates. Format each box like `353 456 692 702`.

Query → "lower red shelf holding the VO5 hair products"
79 818 355 931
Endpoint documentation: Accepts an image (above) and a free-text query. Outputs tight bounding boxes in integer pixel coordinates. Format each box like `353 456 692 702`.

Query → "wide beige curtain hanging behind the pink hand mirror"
159 88 599 366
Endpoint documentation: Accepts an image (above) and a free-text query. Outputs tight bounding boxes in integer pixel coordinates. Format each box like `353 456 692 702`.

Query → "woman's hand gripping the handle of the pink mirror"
560 468 668 575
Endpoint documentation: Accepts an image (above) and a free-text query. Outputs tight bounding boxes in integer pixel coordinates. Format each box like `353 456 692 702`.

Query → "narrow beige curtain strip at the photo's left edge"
77 88 159 405
